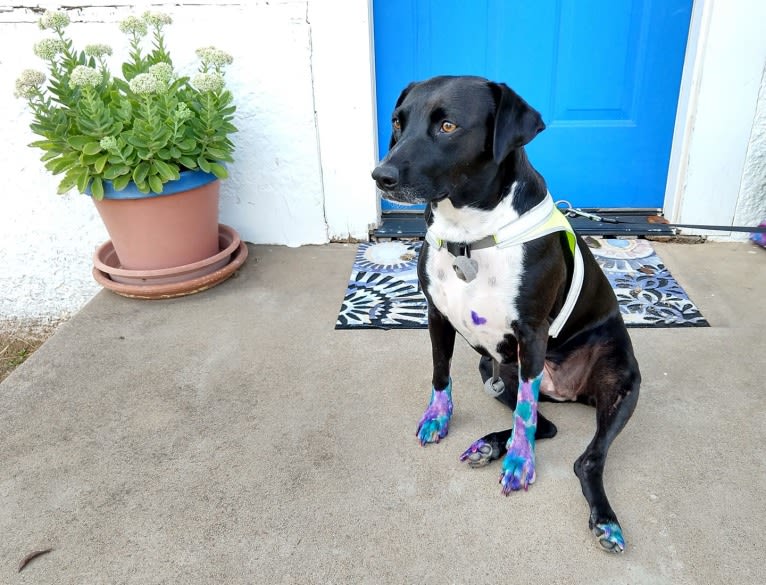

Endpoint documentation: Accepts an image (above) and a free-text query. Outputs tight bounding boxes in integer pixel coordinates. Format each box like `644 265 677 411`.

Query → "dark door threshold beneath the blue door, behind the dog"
370 209 675 241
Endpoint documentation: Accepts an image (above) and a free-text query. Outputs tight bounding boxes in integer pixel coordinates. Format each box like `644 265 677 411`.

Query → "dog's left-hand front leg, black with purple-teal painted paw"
416 306 455 445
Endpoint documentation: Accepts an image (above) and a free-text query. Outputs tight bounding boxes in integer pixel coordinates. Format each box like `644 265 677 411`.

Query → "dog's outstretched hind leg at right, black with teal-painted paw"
574 355 641 552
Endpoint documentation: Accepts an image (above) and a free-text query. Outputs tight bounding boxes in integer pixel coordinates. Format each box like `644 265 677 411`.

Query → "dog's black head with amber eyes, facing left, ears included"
372 77 545 207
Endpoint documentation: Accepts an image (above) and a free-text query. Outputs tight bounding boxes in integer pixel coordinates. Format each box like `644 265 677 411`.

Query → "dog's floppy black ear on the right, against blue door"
489 82 545 164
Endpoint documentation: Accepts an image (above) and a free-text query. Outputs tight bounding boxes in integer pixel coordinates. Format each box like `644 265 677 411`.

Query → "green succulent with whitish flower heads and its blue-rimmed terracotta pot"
16 11 246 296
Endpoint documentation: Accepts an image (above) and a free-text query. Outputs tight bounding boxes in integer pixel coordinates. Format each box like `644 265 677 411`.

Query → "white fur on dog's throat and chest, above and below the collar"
426 192 524 361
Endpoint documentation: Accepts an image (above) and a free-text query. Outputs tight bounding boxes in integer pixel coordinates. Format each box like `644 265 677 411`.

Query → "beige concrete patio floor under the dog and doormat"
0 243 766 585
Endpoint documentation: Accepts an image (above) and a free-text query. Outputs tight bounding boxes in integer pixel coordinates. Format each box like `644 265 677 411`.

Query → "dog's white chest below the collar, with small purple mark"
426 246 523 361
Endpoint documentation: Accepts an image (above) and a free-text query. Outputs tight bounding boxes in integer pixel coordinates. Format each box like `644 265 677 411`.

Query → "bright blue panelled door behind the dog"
373 0 692 211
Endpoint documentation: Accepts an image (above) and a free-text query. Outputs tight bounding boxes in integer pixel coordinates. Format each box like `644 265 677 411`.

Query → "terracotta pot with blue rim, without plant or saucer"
93 171 220 270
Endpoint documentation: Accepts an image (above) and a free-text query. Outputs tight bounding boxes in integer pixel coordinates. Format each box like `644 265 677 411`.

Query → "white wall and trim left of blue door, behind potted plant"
0 0 377 318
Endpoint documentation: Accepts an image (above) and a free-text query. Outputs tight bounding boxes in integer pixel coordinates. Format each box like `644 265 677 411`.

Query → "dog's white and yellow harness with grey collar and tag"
426 193 584 337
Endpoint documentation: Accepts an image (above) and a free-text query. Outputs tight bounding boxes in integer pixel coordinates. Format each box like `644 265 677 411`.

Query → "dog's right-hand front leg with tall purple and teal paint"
500 322 548 496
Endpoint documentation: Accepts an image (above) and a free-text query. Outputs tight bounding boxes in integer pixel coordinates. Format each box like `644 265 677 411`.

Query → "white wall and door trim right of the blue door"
665 0 766 240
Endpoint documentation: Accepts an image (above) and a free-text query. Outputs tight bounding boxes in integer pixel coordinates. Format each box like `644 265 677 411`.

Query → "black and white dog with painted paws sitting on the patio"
372 76 641 552
